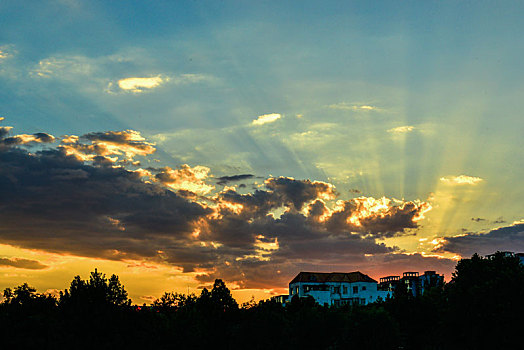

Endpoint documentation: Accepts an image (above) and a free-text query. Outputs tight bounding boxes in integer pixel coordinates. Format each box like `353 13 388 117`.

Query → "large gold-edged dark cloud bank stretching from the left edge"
0 120 450 288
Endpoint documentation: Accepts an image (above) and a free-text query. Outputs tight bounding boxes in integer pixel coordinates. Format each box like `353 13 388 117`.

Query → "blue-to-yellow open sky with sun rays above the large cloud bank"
0 0 524 300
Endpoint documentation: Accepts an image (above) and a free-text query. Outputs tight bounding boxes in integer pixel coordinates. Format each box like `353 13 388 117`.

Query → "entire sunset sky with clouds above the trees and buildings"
0 0 524 304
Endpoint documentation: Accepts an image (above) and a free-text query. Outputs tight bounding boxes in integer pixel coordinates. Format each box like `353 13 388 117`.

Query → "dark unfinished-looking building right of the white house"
378 271 444 297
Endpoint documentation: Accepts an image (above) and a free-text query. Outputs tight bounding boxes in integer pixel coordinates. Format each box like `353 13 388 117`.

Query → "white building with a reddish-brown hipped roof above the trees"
289 271 392 306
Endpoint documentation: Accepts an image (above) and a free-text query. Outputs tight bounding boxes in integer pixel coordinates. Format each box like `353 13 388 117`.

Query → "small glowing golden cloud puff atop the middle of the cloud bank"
155 164 215 195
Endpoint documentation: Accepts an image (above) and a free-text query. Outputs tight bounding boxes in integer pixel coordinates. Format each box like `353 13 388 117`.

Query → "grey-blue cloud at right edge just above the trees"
438 223 524 257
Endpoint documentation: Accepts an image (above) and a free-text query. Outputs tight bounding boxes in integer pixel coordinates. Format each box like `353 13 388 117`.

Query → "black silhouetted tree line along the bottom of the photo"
0 253 524 349
